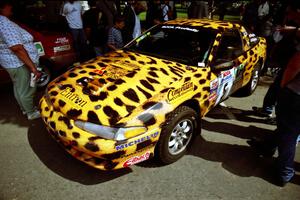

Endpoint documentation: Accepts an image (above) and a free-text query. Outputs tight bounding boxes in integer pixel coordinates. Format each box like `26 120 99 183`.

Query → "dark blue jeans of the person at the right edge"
276 88 300 181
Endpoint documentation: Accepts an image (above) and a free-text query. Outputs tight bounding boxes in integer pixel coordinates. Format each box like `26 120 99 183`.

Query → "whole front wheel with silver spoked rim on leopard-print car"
156 106 198 164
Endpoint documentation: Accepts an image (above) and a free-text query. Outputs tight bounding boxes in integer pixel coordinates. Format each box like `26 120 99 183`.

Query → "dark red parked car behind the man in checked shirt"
0 23 76 87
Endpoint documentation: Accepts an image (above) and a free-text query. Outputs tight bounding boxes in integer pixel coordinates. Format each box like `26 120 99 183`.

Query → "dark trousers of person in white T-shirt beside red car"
70 28 88 61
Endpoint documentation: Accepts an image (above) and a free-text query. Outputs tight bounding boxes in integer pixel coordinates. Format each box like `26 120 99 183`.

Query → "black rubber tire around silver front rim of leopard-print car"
155 106 198 164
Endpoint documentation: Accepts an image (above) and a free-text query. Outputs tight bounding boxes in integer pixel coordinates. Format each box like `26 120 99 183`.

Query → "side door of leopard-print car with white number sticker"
211 29 246 104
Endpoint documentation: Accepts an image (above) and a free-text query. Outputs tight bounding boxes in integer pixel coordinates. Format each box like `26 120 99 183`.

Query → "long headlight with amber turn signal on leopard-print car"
75 121 147 141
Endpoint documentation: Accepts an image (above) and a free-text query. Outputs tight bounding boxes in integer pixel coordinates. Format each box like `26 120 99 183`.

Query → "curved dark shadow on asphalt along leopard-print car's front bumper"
28 120 132 185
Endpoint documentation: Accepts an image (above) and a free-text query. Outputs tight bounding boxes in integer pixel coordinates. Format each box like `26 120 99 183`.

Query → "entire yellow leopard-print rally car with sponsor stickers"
40 19 266 170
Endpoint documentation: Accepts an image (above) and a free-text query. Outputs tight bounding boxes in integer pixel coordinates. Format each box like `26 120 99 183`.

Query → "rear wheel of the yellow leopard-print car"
238 62 262 96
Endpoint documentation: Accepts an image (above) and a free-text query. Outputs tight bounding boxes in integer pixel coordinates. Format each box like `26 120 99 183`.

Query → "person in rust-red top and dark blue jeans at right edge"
276 48 300 186
